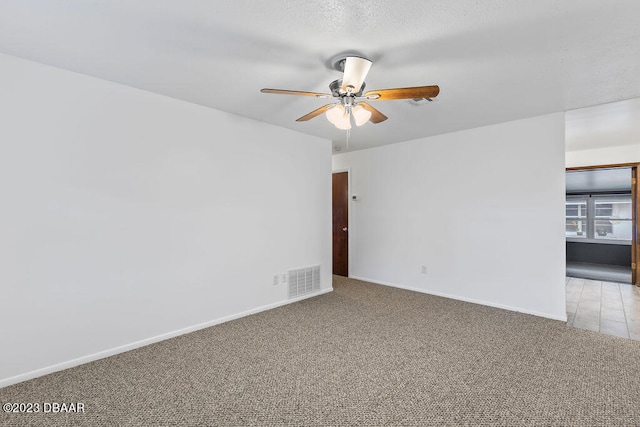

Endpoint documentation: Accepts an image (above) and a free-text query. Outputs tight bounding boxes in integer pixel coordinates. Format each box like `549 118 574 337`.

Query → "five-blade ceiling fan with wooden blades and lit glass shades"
260 55 440 130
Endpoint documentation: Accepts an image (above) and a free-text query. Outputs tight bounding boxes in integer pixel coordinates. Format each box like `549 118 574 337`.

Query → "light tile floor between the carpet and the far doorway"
566 277 640 341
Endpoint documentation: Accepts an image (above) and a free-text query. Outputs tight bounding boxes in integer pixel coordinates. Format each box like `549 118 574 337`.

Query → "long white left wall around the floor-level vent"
0 55 331 386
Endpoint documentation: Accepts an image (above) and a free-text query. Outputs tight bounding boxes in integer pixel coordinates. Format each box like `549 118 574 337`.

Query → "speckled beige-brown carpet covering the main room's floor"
0 278 640 426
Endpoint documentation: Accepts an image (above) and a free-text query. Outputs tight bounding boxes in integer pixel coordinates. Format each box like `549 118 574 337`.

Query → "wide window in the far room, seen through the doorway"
565 195 632 243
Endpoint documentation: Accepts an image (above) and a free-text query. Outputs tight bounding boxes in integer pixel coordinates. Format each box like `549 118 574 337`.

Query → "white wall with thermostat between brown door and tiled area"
333 113 566 320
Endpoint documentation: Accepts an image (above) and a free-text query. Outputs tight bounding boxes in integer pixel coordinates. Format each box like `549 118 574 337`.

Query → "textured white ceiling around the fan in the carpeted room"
0 0 640 150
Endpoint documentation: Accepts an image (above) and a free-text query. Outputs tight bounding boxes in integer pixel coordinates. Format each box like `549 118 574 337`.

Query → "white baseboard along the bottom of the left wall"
0 288 333 388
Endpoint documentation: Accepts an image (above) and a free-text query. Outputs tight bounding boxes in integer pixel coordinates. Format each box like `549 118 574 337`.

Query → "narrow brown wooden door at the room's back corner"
332 172 349 277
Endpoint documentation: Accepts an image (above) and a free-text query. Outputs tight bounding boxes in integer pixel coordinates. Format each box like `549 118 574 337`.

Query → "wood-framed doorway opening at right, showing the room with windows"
565 164 639 284
